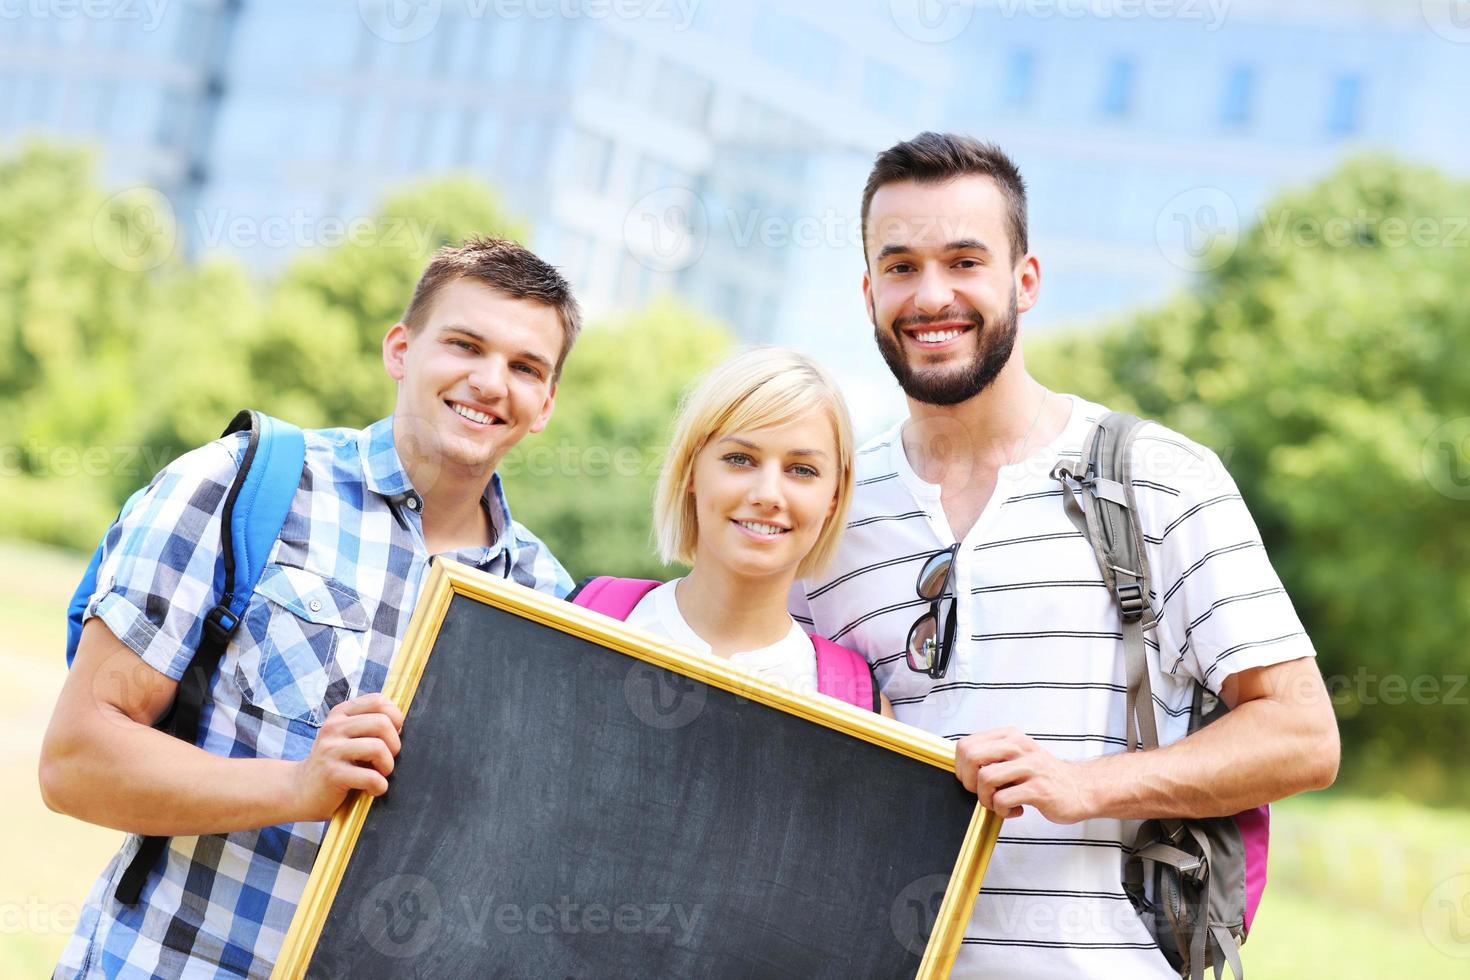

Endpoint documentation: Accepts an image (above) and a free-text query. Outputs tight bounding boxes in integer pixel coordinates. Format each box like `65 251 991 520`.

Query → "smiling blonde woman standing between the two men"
570 347 892 717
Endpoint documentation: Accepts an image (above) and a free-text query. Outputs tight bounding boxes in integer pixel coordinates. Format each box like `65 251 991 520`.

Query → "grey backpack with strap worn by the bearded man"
1051 411 1270 980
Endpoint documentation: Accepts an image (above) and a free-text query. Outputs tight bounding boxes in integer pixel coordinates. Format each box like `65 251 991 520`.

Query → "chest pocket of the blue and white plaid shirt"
235 564 369 729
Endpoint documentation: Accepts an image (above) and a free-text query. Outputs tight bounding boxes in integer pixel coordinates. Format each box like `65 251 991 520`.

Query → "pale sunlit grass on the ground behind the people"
0 541 1470 980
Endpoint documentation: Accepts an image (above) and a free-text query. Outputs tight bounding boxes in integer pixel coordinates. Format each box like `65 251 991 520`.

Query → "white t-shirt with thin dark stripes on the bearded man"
792 397 1314 980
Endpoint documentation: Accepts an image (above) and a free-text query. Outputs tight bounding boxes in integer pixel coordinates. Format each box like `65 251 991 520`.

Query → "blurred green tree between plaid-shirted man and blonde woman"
501 300 734 579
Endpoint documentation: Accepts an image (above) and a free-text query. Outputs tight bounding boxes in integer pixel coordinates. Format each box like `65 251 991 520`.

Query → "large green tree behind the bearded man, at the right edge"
1032 159 1470 798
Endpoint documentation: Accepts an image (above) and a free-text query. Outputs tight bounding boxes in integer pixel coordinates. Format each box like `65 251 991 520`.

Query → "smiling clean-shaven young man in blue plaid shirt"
41 239 579 977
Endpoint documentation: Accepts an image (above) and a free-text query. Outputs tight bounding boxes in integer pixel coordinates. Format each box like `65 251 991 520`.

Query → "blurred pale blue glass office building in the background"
0 0 1470 348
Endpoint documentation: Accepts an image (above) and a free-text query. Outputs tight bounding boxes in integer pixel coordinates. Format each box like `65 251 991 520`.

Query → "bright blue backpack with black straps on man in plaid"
66 410 306 905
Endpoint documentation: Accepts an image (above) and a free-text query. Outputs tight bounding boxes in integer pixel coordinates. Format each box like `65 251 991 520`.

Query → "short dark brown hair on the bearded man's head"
861 132 1029 264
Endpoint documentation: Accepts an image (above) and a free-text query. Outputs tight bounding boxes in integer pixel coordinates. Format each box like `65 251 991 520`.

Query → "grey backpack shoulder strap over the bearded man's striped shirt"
1051 411 1158 751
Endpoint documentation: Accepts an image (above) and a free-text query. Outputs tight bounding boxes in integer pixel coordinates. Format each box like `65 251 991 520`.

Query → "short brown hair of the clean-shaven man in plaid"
403 237 582 381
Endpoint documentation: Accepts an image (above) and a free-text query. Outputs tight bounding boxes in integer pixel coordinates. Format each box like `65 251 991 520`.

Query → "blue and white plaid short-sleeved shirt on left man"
56 417 572 977
